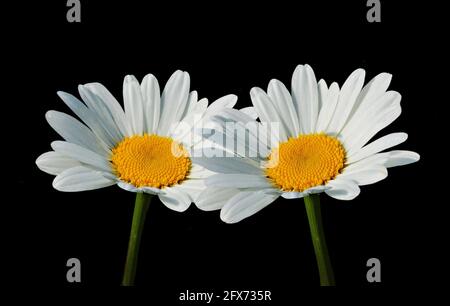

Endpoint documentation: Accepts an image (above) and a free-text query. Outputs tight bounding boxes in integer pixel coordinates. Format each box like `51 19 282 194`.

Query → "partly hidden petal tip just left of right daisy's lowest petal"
195 187 239 211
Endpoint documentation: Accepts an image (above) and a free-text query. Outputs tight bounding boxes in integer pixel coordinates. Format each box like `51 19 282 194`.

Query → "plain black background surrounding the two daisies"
2 0 448 301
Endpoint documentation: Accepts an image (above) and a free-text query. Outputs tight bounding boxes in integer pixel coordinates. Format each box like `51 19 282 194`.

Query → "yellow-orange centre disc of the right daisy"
266 134 345 192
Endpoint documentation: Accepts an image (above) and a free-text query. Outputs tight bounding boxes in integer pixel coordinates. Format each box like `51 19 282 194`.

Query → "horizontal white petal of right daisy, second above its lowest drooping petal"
206 174 272 188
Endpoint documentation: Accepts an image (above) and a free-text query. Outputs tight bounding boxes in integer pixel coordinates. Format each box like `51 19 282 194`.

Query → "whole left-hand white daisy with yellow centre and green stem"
36 71 237 285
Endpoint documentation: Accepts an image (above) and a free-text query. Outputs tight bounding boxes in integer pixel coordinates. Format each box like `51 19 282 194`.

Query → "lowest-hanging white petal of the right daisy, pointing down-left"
220 190 279 223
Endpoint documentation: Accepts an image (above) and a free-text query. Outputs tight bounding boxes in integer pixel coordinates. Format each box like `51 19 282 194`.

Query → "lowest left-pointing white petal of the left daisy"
53 166 116 192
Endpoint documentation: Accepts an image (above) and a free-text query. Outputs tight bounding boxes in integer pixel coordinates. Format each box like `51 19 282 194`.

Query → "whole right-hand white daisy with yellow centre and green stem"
196 65 419 284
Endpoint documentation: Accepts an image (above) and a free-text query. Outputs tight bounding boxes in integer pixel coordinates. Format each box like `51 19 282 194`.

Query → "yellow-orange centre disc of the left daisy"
111 134 191 188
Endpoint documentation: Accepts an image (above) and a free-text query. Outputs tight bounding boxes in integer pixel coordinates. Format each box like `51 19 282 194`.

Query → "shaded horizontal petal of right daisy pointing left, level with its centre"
192 157 262 174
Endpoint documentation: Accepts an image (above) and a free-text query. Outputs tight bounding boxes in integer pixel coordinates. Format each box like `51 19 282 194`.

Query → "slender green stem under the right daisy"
304 194 335 286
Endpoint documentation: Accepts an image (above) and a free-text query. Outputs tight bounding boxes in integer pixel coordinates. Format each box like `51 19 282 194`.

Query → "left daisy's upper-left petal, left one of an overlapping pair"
78 85 123 142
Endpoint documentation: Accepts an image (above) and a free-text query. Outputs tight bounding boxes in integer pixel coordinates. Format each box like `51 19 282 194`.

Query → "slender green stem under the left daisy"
122 193 152 286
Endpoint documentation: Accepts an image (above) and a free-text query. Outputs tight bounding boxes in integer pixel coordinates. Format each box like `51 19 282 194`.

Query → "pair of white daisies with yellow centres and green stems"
36 65 419 283
